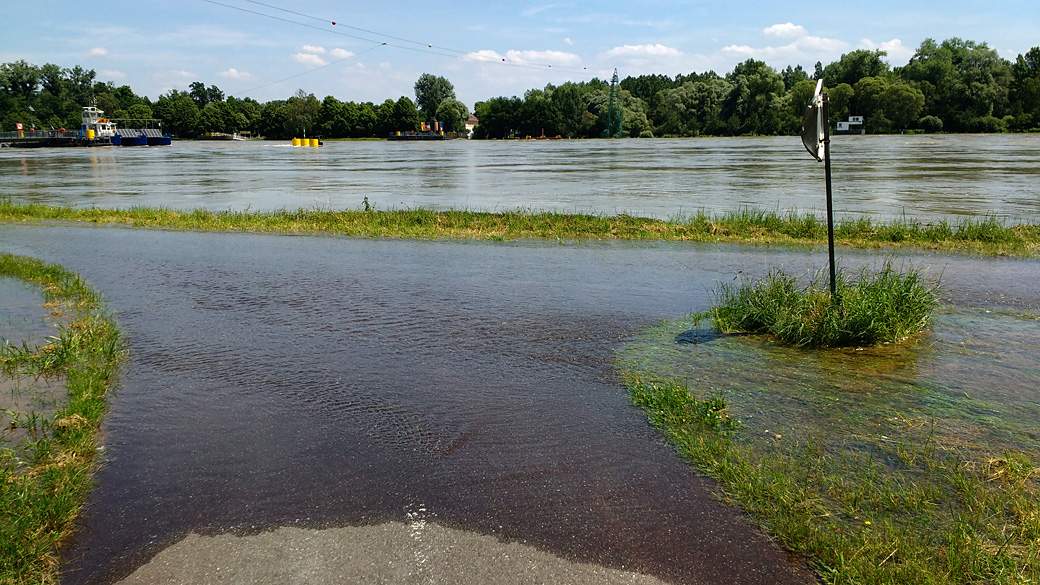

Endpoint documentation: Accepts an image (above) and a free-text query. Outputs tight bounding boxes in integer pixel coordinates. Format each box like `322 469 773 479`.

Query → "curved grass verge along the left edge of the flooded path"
0 254 124 584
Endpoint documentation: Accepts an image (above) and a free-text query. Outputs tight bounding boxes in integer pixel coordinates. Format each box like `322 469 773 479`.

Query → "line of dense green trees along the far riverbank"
0 37 1040 139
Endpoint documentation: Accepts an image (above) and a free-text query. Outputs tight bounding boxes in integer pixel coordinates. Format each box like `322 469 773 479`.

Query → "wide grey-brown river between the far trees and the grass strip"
6 134 1040 223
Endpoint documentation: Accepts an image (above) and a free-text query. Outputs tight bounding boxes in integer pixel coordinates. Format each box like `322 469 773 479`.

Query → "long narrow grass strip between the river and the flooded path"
6 198 1040 256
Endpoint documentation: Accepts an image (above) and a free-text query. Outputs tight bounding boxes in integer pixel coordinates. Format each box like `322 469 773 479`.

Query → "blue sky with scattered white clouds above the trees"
0 0 1040 109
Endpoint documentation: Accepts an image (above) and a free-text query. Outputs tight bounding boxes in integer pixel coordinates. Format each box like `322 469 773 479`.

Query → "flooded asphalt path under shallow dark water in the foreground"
0 225 1037 584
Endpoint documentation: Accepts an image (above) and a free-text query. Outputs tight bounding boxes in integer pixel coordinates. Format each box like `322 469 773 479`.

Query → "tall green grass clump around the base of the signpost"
707 263 937 347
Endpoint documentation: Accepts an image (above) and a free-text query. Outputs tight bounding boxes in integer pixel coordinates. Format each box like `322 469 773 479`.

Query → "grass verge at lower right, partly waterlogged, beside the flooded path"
623 371 1040 585
